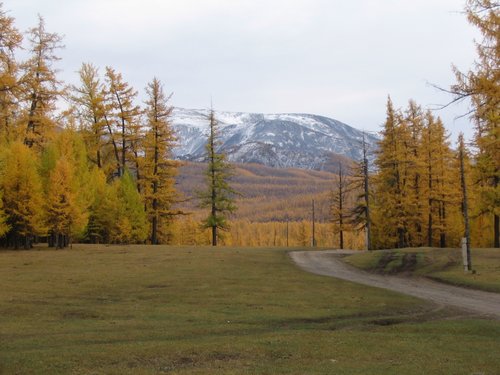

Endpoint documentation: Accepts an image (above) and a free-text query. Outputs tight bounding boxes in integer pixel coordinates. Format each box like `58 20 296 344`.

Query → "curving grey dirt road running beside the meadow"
290 250 500 319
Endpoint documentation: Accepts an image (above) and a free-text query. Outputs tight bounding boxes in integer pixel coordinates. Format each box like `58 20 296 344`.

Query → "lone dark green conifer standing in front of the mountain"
200 109 238 246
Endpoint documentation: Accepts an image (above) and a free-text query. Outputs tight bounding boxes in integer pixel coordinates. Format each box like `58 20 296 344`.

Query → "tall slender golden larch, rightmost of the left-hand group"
142 78 178 245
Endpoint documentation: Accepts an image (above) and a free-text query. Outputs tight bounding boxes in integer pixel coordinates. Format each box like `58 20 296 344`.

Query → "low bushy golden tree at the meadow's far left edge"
0 142 45 249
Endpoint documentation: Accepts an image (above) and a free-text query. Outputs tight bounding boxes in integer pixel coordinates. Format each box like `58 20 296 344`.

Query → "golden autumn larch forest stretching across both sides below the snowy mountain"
0 0 500 250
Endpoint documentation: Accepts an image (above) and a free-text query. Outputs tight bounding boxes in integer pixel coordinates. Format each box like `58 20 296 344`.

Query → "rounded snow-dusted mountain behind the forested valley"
172 108 377 170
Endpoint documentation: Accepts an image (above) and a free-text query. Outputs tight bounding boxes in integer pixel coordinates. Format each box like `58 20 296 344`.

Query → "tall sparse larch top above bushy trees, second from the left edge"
20 17 62 148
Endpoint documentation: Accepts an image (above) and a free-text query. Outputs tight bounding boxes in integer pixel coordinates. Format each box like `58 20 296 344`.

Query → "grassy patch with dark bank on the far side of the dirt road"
344 248 500 293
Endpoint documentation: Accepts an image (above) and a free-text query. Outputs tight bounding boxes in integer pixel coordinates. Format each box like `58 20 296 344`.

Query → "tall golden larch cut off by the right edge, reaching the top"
451 0 500 248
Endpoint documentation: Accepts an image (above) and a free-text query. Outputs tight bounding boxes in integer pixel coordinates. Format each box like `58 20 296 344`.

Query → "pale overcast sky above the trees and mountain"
3 0 480 140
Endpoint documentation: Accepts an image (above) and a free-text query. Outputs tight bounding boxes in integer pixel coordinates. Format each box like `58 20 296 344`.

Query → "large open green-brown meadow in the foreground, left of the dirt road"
0 246 500 375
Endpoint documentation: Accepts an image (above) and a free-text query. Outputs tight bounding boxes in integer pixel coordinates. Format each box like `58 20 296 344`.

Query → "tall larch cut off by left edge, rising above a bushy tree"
0 3 23 143
